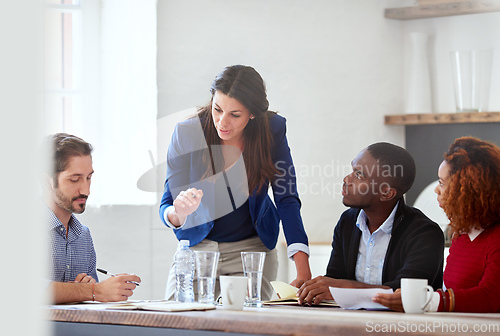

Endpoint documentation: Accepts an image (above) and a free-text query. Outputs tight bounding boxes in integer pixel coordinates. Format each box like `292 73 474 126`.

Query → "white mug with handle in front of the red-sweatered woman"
401 278 434 314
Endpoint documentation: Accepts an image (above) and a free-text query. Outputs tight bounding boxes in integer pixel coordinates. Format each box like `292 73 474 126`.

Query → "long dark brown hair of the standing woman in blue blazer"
198 65 278 194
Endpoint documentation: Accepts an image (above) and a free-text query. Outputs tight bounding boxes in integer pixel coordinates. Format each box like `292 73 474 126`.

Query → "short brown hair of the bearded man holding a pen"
48 133 93 178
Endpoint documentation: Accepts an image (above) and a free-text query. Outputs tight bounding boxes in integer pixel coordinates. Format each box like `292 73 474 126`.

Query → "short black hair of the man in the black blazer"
367 142 416 197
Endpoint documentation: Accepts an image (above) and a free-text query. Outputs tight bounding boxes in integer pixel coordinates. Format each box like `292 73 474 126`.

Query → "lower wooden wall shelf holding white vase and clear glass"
384 112 500 125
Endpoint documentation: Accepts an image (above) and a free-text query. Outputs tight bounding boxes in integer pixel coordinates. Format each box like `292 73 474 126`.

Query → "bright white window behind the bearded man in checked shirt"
43 0 158 206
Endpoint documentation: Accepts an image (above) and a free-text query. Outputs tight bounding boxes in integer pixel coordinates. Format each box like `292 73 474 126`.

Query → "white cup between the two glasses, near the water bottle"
219 275 248 310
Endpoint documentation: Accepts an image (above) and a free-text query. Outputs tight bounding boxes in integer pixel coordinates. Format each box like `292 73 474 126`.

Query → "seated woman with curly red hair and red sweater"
373 137 500 313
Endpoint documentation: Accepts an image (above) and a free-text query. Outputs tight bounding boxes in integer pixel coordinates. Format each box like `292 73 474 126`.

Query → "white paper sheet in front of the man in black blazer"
330 287 393 310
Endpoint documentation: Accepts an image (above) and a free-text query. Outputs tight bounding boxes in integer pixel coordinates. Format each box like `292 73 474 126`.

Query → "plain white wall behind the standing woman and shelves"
82 0 500 299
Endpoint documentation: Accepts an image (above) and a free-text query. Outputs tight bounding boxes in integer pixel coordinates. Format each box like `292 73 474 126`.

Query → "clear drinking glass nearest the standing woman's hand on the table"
241 252 266 307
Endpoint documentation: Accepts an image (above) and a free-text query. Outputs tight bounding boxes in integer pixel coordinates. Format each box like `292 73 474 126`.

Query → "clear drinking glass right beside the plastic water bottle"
195 251 220 303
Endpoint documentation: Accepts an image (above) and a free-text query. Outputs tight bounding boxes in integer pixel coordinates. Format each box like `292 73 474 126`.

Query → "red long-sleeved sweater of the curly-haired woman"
439 225 500 313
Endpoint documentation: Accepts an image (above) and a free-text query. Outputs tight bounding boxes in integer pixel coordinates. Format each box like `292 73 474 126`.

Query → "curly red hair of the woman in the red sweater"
442 137 500 235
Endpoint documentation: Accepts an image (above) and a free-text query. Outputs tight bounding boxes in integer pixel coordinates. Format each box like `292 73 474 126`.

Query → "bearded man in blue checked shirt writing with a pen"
43 133 141 303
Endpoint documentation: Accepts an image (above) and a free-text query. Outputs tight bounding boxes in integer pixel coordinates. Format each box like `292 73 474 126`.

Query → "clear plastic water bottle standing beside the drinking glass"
174 240 195 302
